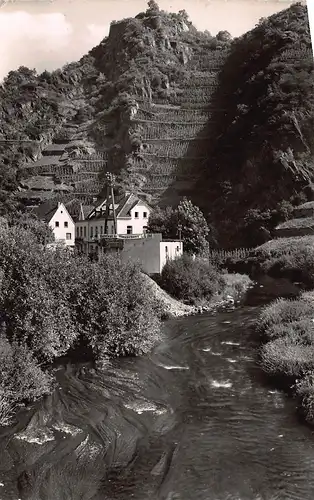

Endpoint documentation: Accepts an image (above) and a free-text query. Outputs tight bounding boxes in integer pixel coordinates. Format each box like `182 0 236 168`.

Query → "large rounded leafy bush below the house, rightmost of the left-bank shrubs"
72 255 159 357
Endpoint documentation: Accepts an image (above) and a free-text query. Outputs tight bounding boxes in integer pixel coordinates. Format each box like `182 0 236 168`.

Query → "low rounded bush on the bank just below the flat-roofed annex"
159 255 225 304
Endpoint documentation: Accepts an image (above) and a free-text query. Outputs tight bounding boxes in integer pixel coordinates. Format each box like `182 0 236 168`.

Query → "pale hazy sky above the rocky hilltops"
0 0 314 79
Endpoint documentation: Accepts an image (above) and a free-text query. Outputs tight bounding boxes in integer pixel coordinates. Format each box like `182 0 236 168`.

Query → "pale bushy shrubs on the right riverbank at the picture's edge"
259 292 314 423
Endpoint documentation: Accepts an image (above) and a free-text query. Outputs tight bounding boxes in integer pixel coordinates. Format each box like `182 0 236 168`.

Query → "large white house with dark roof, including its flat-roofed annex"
75 193 183 274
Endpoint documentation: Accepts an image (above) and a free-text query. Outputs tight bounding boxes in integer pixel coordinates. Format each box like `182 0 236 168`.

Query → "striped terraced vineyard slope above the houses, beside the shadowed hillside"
125 47 227 205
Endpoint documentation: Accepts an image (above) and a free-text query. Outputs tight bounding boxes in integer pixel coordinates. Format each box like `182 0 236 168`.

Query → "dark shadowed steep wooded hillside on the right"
195 4 314 247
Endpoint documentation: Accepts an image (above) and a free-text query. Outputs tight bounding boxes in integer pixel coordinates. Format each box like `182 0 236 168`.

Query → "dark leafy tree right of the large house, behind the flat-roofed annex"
148 198 209 255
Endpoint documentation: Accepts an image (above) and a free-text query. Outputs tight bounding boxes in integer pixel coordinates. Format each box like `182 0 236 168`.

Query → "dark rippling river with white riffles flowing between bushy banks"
0 278 314 500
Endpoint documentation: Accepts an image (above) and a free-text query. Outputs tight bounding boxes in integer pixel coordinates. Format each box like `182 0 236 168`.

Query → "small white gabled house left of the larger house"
32 202 75 247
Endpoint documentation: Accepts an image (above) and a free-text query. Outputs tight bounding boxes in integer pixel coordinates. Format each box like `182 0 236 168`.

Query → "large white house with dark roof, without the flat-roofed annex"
75 193 152 253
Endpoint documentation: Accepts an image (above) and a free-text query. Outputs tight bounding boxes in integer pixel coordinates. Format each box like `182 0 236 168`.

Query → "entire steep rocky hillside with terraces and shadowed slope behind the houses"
0 1 314 247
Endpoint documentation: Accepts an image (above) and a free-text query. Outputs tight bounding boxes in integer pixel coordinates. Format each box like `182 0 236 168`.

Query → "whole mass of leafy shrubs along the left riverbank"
0 217 159 424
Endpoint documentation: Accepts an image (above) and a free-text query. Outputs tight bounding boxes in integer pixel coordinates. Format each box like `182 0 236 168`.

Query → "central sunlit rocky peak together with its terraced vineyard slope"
90 3 231 204
